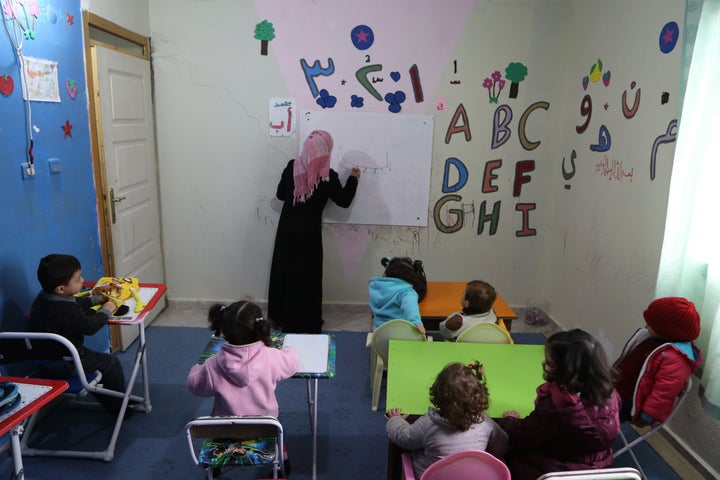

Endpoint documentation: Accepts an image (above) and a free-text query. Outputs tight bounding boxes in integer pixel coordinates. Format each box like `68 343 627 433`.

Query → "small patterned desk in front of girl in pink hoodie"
197 333 337 480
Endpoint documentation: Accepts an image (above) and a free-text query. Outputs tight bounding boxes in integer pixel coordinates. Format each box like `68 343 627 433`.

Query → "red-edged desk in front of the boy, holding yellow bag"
85 282 167 412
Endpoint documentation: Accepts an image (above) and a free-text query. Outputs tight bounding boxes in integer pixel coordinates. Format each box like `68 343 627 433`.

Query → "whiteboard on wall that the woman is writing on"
298 110 434 227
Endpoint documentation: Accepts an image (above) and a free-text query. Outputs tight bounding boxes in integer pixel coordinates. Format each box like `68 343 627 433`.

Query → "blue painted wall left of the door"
0 0 107 348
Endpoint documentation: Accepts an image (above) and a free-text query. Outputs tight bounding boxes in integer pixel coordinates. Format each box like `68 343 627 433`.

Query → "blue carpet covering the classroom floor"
0 326 679 480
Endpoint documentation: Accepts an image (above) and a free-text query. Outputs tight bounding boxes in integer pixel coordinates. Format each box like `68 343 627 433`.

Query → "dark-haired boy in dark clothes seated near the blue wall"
30 253 125 414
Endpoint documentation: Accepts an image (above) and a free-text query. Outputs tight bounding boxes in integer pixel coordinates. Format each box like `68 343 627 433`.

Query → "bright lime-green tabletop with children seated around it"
386 340 545 418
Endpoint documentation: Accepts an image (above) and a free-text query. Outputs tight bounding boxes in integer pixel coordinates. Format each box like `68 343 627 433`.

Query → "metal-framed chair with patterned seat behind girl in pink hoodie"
185 415 285 480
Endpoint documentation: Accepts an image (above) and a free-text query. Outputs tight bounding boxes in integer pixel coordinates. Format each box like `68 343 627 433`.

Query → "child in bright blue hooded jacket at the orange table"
368 258 425 334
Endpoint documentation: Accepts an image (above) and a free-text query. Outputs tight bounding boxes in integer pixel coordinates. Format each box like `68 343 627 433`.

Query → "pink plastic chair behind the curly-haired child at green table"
401 450 510 480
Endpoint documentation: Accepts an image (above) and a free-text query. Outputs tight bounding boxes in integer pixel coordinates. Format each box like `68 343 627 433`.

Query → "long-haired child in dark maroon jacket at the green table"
498 329 620 480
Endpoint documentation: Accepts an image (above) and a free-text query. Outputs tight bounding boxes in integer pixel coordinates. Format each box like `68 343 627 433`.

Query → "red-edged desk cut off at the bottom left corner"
0 376 68 480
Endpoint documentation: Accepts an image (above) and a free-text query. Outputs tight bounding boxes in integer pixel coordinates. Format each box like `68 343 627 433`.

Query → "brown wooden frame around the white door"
83 11 152 277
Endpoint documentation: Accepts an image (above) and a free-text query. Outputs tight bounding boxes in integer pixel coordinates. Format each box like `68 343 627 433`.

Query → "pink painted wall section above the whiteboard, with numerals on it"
255 0 475 114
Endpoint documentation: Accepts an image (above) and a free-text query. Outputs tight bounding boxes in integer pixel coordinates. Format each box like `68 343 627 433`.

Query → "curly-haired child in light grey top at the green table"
385 362 508 478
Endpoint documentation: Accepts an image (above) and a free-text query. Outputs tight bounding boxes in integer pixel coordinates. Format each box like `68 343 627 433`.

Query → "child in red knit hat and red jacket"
613 297 702 426
